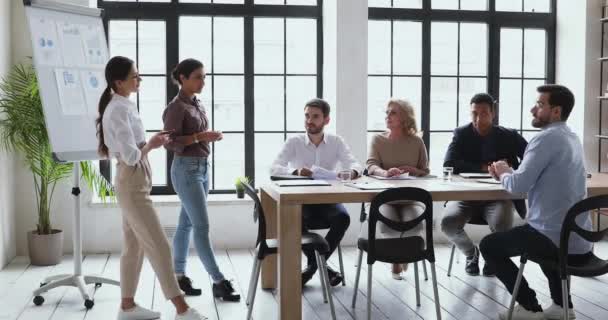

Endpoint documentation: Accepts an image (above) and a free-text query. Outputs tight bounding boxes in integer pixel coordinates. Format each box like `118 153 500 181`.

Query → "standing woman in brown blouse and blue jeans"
163 59 241 301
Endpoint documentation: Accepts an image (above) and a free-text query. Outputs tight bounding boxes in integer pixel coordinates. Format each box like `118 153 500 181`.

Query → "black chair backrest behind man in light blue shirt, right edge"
559 195 608 274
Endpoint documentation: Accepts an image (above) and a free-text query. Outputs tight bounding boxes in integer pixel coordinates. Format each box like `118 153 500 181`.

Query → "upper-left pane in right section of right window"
500 28 522 77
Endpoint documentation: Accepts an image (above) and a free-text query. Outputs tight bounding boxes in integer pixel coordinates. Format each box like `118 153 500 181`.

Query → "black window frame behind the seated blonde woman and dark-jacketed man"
367 0 557 155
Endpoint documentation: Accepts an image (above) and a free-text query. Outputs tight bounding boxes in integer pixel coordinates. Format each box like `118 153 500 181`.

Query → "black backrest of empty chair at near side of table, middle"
368 187 435 263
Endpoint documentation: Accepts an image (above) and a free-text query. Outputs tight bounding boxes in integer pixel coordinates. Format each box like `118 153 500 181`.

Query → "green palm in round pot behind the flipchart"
0 65 112 265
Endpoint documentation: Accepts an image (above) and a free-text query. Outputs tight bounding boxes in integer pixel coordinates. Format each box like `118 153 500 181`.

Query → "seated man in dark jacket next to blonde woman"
441 93 527 276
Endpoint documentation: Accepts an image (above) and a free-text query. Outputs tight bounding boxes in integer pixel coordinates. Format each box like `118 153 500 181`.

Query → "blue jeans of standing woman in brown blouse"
171 156 224 282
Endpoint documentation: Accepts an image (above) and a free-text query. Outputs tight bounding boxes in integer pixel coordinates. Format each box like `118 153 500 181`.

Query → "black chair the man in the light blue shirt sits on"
508 195 608 320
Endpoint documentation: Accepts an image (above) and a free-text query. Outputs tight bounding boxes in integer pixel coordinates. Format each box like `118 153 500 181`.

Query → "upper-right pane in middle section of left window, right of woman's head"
213 18 244 73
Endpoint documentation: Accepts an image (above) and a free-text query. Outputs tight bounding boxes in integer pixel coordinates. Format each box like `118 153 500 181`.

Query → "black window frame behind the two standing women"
97 0 323 195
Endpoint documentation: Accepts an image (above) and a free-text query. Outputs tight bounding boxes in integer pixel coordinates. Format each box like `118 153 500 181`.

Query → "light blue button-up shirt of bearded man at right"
501 122 591 254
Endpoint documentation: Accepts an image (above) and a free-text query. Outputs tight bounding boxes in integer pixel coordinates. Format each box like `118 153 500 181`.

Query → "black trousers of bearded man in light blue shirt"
479 224 589 311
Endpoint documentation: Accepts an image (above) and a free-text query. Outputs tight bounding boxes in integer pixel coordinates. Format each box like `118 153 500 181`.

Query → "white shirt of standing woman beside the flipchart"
102 94 146 166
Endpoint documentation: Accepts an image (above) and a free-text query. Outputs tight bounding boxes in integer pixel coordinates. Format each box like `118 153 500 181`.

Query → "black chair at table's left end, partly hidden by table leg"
243 183 336 320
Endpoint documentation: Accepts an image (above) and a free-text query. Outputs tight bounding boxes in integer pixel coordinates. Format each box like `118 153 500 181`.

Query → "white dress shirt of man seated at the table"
270 133 363 175
